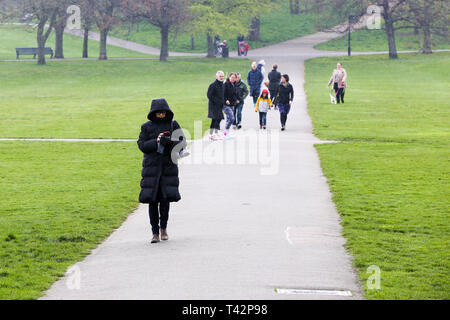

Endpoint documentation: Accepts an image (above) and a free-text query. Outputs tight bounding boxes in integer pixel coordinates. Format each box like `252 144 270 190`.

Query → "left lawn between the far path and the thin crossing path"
0 59 250 139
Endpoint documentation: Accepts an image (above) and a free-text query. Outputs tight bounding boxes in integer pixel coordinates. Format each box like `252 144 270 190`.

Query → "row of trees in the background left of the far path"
0 0 279 64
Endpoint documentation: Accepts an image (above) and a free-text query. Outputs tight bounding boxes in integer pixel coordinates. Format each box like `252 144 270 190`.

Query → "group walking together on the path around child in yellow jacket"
207 60 294 140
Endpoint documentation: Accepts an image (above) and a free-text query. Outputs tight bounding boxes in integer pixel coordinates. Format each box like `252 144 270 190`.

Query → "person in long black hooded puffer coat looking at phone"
137 99 186 243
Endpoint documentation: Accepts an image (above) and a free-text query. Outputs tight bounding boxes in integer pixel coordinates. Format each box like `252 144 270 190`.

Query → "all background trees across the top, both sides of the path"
0 0 450 64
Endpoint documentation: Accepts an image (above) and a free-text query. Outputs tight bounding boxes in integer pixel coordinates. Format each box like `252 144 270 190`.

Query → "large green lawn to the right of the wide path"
306 53 450 299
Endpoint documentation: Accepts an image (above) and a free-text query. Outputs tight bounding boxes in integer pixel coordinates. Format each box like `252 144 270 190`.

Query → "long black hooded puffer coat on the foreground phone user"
137 99 186 203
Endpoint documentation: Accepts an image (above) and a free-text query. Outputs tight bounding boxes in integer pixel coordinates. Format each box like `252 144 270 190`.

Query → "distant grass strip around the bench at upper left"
0 25 151 59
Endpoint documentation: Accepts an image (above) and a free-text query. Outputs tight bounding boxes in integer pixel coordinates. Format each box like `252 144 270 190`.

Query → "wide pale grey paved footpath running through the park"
39 28 370 299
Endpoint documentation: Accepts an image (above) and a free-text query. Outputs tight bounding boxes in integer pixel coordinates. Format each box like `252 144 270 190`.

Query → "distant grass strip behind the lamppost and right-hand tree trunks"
316 29 450 52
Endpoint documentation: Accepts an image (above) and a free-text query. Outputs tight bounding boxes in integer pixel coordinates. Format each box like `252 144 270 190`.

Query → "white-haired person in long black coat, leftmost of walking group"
206 71 225 140
